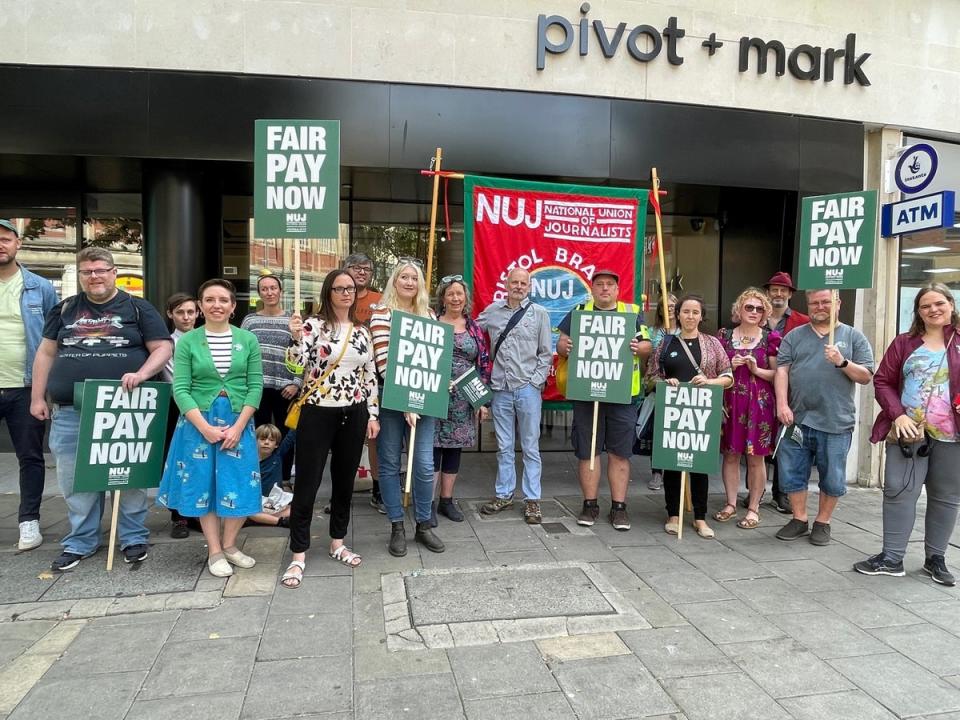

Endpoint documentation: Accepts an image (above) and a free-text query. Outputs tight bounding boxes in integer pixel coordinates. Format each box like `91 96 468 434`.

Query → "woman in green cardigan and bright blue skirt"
157 279 263 577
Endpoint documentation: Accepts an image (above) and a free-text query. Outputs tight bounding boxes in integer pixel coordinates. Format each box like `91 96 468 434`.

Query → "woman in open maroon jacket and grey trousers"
853 283 960 585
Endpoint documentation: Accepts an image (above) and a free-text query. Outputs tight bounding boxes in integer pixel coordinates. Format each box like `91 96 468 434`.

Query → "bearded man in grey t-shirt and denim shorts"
774 290 873 545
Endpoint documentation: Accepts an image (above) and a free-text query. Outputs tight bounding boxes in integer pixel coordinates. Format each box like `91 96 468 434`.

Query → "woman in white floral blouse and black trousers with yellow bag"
281 270 380 588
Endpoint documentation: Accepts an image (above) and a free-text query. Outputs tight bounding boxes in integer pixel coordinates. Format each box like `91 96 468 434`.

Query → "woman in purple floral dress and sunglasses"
713 287 780 530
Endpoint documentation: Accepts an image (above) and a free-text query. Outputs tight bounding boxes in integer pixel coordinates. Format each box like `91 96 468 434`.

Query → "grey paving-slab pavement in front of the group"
0 453 960 720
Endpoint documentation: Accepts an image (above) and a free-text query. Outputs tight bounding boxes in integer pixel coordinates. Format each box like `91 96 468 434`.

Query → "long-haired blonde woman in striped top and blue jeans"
370 258 445 557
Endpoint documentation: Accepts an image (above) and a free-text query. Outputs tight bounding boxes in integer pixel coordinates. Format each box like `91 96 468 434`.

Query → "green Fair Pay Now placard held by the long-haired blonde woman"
381 310 453 418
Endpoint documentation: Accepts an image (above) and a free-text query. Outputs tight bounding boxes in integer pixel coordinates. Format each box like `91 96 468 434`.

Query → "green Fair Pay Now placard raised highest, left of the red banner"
253 120 340 238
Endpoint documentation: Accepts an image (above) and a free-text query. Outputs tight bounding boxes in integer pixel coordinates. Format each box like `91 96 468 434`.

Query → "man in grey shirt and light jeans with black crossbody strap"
477 268 553 524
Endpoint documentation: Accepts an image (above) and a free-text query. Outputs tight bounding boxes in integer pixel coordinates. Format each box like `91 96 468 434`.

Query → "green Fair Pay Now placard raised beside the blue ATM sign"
797 190 877 290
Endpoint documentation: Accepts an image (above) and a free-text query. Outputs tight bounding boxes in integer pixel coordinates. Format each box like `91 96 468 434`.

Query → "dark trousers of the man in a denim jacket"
0 387 46 522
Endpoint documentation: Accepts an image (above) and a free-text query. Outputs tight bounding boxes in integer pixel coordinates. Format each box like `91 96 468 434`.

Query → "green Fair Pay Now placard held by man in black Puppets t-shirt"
73 380 170 492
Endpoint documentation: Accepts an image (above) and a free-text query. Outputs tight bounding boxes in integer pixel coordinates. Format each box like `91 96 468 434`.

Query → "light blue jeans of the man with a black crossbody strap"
491 384 543 500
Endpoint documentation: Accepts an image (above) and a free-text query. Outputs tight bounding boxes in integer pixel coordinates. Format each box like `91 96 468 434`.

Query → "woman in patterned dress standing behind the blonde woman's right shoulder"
433 275 491 527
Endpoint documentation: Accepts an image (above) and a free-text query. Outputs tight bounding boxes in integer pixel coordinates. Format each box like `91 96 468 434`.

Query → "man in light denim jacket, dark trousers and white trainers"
0 220 57 550
